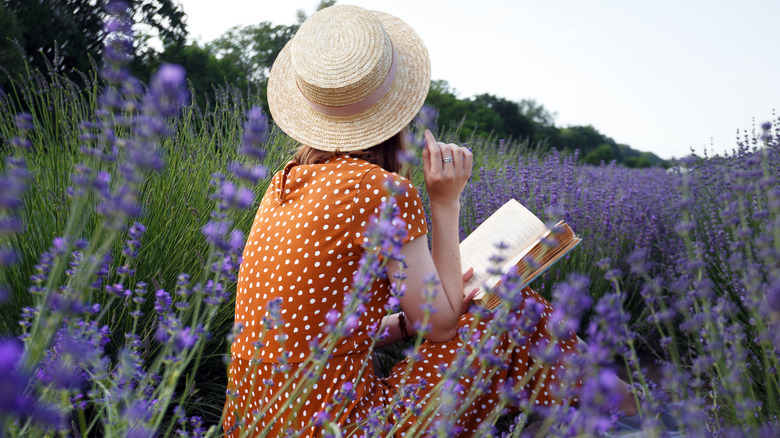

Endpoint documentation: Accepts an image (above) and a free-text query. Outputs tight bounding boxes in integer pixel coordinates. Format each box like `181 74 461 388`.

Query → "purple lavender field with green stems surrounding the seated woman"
0 6 780 437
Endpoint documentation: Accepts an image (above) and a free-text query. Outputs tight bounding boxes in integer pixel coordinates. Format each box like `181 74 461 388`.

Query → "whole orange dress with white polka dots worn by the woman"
223 156 576 437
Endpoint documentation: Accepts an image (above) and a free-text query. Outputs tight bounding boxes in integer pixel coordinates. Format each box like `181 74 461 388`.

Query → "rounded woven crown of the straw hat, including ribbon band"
291 6 393 107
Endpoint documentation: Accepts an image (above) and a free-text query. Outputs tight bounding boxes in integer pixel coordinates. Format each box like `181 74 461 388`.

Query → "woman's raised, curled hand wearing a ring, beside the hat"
423 129 474 205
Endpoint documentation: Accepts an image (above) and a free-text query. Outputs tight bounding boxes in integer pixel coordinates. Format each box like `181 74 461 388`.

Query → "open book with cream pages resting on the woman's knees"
460 199 580 310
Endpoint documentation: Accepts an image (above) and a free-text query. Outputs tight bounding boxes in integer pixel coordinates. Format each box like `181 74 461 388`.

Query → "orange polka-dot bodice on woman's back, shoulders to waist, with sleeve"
232 156 427 363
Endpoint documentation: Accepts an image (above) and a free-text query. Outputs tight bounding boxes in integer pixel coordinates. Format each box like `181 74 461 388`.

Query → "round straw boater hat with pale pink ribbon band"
268 5 431 152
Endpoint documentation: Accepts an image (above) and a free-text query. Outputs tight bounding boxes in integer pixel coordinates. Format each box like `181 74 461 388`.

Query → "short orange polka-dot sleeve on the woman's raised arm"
353 167 428 248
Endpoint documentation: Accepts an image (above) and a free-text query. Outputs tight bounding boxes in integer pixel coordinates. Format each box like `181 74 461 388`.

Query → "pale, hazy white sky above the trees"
180 0 780 158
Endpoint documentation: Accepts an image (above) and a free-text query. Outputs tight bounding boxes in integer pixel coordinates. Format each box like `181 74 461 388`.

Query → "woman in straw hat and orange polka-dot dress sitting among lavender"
224 6 636 436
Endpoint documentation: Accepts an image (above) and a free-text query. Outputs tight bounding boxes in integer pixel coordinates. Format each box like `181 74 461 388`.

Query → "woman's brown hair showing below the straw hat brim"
295 128 410 178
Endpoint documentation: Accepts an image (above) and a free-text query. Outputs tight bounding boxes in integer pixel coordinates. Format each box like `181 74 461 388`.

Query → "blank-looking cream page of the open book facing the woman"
460 199 547 296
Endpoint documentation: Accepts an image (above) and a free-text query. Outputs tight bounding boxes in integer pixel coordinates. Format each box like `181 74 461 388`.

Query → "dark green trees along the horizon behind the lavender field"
0 0 668 167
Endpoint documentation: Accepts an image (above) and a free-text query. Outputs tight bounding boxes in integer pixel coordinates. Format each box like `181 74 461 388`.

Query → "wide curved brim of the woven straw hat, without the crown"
268 11 431 152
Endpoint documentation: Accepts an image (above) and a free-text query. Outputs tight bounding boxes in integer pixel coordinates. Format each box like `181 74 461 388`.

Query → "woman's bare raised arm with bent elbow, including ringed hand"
388 130 473 342
